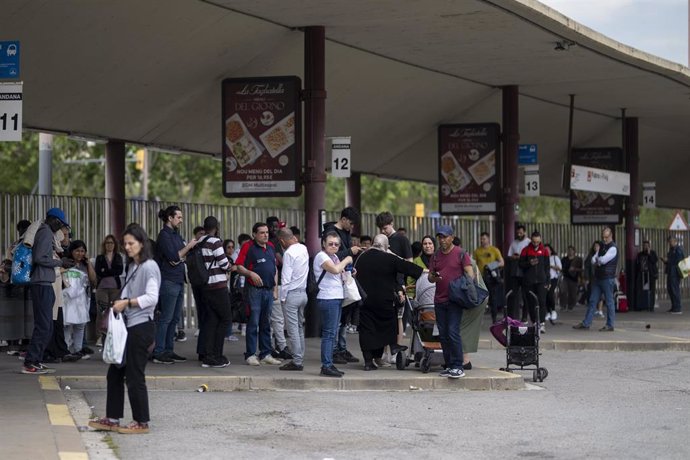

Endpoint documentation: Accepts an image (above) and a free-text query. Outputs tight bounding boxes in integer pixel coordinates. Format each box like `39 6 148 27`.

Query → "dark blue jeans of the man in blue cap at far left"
24 284 55 366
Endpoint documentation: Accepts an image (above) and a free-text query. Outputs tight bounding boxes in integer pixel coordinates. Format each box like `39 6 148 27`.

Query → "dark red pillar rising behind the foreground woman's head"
105 141 125 238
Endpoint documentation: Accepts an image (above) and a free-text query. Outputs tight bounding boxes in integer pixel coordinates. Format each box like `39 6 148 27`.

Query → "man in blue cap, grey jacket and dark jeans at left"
22 208 74 374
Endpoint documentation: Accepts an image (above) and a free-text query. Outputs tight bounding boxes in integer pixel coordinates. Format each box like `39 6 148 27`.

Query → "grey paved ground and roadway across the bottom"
0 309 690 459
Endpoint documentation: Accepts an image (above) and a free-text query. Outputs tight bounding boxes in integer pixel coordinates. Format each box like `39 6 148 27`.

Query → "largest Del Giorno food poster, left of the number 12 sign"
222 77 302 198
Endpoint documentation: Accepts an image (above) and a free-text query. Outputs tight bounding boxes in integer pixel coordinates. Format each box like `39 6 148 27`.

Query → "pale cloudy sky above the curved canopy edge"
539 0 688 66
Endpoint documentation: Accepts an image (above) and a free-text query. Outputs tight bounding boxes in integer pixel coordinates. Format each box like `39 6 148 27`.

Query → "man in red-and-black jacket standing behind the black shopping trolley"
520 231 551 332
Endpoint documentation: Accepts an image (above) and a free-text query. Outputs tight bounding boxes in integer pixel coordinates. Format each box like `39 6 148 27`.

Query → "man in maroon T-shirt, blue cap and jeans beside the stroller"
429 225 474 379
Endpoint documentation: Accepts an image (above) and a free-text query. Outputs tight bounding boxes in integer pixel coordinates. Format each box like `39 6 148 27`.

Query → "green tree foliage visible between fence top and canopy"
0 133 675 228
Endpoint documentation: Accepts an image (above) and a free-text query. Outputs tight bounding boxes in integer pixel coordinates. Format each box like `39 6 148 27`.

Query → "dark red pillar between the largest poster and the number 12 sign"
304 26 326 337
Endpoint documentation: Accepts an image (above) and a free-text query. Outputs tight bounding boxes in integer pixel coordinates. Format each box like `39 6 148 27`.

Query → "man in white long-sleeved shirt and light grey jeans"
277 228 309 371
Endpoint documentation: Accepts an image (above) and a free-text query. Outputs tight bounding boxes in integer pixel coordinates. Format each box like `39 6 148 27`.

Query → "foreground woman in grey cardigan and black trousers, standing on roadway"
89 224 161 434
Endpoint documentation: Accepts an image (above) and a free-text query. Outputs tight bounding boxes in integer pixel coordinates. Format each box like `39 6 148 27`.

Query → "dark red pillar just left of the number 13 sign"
496 85 520 254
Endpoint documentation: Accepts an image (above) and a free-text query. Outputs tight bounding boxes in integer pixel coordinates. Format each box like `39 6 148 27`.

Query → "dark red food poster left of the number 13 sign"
438 123 501 215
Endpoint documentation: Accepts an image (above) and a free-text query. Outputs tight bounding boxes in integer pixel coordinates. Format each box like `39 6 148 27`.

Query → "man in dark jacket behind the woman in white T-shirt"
323 206 362 364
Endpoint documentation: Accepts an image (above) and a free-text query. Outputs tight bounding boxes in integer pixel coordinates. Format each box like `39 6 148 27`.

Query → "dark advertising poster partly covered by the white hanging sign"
570 147 625 224
